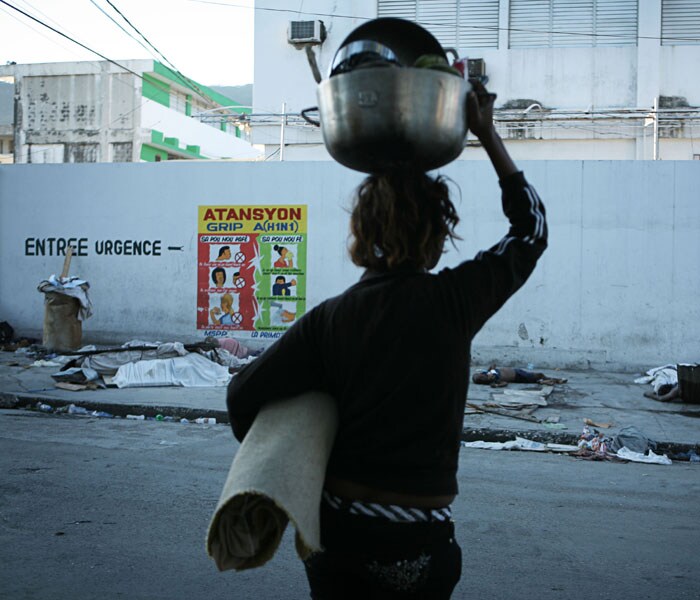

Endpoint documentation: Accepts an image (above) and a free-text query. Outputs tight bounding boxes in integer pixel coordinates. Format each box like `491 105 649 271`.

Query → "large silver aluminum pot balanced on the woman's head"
317 67 471 173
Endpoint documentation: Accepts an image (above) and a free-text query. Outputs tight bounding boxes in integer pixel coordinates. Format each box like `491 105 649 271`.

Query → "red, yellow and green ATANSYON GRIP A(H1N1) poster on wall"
197 205 307 339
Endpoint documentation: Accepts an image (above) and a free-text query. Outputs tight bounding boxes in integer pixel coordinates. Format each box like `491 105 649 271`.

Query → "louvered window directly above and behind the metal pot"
377 0 499 48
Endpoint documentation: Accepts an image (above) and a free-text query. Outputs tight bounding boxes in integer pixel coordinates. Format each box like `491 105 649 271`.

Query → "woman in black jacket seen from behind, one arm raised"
227 83 547 600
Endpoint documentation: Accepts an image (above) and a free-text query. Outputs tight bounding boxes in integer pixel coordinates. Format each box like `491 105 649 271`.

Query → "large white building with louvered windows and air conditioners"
252 0 700 160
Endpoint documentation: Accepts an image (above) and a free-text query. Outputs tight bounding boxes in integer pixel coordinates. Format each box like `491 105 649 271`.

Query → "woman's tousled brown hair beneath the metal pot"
349 170 459 271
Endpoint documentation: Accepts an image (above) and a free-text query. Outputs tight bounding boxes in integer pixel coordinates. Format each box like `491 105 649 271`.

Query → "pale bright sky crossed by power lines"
0 0 253 85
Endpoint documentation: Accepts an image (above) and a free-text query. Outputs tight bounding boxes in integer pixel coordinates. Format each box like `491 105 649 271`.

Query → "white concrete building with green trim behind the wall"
0 60 261 163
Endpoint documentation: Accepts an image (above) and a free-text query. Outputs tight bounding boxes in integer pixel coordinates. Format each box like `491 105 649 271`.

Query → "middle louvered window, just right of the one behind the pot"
509 0 637 48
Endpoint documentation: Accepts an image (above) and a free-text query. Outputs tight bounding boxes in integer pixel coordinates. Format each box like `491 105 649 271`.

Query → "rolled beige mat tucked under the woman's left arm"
206 392 338 571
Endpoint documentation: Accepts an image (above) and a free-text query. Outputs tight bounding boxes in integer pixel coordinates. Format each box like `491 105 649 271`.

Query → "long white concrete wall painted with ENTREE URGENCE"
0 161 700 368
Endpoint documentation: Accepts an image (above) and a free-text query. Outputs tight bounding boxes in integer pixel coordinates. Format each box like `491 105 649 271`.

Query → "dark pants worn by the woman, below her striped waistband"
304 502 462 600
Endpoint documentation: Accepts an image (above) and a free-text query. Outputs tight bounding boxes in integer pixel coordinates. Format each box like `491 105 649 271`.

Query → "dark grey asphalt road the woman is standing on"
0 411 700 600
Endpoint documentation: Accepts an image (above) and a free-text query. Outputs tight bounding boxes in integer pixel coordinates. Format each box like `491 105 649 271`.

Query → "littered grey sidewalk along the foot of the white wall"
0 352 700 453
